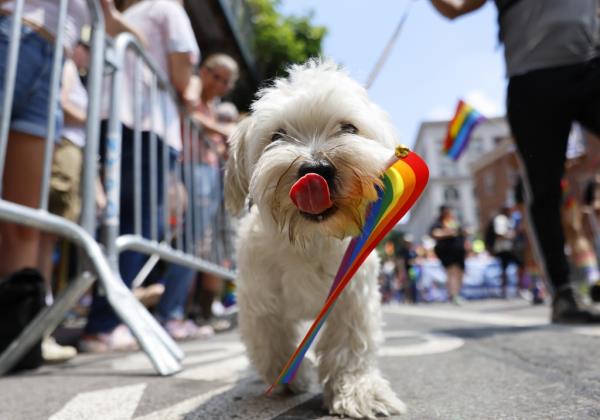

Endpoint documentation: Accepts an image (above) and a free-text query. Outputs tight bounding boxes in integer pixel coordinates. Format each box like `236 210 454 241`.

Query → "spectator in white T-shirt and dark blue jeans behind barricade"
79 0 200 352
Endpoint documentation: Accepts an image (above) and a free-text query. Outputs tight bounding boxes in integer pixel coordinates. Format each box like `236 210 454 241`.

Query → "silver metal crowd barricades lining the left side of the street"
0 0 233 376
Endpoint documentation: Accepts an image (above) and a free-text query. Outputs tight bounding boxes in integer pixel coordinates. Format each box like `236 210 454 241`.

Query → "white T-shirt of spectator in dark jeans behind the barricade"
120 0 200 150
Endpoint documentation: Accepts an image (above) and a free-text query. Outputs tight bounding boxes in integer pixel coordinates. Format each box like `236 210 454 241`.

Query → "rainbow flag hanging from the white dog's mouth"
267 146 429 394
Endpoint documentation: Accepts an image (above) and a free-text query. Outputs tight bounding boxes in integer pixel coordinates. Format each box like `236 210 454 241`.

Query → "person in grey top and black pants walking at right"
431 0 600 323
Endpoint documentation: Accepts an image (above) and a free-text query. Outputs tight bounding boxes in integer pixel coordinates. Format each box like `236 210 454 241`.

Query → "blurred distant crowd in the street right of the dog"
380 177 600 305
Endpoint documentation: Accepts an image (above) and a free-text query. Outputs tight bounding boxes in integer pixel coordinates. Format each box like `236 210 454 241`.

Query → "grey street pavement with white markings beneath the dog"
0 299 600 420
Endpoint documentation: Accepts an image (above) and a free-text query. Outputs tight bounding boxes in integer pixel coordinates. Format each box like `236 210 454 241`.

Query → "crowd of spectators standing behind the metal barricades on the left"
0 0 244 368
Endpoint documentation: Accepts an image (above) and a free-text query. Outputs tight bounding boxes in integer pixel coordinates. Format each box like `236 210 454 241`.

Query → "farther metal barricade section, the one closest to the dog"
104 33 235 280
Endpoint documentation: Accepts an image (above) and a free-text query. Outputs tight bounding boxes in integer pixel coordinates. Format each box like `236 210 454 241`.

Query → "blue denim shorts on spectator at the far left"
0 15 63 141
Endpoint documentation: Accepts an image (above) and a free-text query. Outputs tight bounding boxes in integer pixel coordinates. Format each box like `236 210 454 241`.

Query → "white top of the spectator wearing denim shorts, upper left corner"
2 0 89 51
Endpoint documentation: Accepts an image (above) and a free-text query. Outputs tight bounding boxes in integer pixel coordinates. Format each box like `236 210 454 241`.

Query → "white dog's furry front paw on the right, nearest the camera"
325 374 406 419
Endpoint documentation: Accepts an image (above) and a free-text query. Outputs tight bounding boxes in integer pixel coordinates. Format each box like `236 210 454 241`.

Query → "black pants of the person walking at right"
507 59 600 290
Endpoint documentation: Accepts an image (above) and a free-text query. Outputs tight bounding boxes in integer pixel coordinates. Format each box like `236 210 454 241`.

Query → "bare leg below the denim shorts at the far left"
0 131 44 276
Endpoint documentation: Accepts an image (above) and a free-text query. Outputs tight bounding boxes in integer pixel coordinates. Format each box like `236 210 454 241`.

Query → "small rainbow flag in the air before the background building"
443 99 485 161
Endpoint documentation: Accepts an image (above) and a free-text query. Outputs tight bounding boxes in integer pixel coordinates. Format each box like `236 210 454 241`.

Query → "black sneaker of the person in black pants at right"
552 286 600 324
